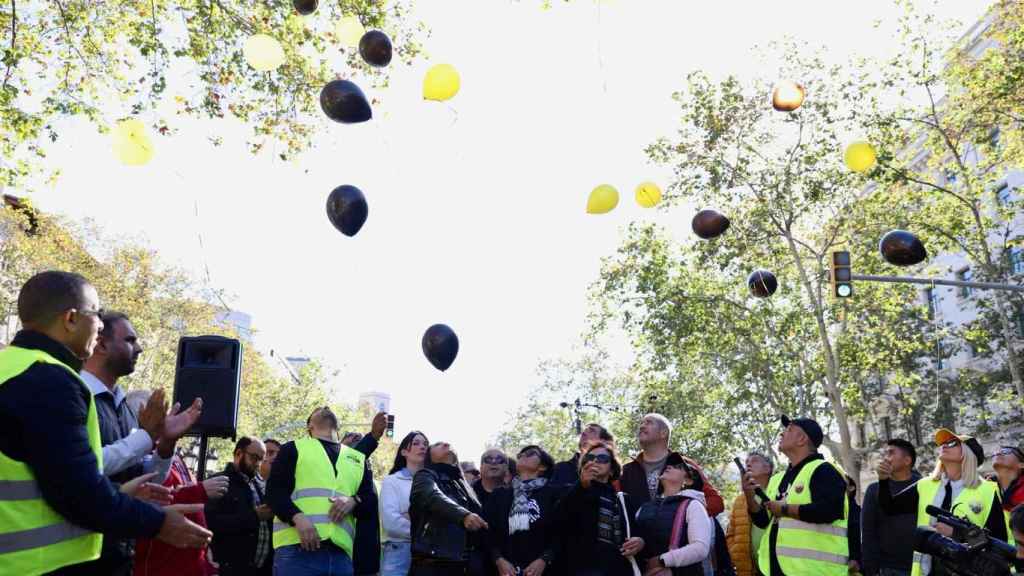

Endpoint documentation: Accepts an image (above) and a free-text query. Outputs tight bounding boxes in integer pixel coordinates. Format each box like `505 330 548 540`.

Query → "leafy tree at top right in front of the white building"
856 1 1024 407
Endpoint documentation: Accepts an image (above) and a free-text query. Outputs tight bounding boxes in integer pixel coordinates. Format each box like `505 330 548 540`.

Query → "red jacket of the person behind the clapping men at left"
134 456 216 576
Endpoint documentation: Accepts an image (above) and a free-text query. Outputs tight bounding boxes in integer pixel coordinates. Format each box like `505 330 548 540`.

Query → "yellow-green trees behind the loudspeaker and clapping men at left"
0 201 395 479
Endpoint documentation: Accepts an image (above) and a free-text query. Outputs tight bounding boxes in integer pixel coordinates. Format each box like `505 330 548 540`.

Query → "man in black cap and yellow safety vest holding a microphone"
743 416 849 576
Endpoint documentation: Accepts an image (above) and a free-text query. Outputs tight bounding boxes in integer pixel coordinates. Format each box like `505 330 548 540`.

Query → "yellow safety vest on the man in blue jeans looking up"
273 438 366 558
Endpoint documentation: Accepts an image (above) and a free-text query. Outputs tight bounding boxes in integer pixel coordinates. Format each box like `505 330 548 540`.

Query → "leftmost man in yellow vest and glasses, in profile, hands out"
0 271 211 576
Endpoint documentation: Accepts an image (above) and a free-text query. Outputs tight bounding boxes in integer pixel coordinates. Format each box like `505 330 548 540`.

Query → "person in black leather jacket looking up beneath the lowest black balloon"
409 442 487 576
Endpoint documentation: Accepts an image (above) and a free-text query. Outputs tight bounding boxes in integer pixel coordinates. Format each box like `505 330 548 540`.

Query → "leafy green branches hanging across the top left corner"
0 0 424 188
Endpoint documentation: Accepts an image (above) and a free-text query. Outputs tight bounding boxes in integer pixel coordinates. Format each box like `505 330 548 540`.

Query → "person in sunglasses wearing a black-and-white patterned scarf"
483 445 558 576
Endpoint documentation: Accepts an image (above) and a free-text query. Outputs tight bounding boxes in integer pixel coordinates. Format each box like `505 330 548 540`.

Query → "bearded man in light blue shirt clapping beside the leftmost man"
81 312 203 576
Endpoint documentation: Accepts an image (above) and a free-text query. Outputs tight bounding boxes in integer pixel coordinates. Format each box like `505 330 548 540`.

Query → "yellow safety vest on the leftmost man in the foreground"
0 346 103 576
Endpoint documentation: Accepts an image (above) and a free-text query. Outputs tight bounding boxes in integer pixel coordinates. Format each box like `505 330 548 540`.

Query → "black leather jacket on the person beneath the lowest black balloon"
409 463 481 563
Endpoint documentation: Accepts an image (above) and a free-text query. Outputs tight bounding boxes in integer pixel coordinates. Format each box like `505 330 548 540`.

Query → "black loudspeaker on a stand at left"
174 336 242 439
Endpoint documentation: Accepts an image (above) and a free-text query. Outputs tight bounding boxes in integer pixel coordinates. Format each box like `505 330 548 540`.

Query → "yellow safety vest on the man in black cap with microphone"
758 460 850 576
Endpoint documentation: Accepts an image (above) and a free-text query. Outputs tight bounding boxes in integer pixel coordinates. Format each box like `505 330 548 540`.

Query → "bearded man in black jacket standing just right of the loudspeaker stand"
205 436 273 576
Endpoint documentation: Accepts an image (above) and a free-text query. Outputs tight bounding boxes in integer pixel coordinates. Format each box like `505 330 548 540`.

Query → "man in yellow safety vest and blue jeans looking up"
267 407 376 576
